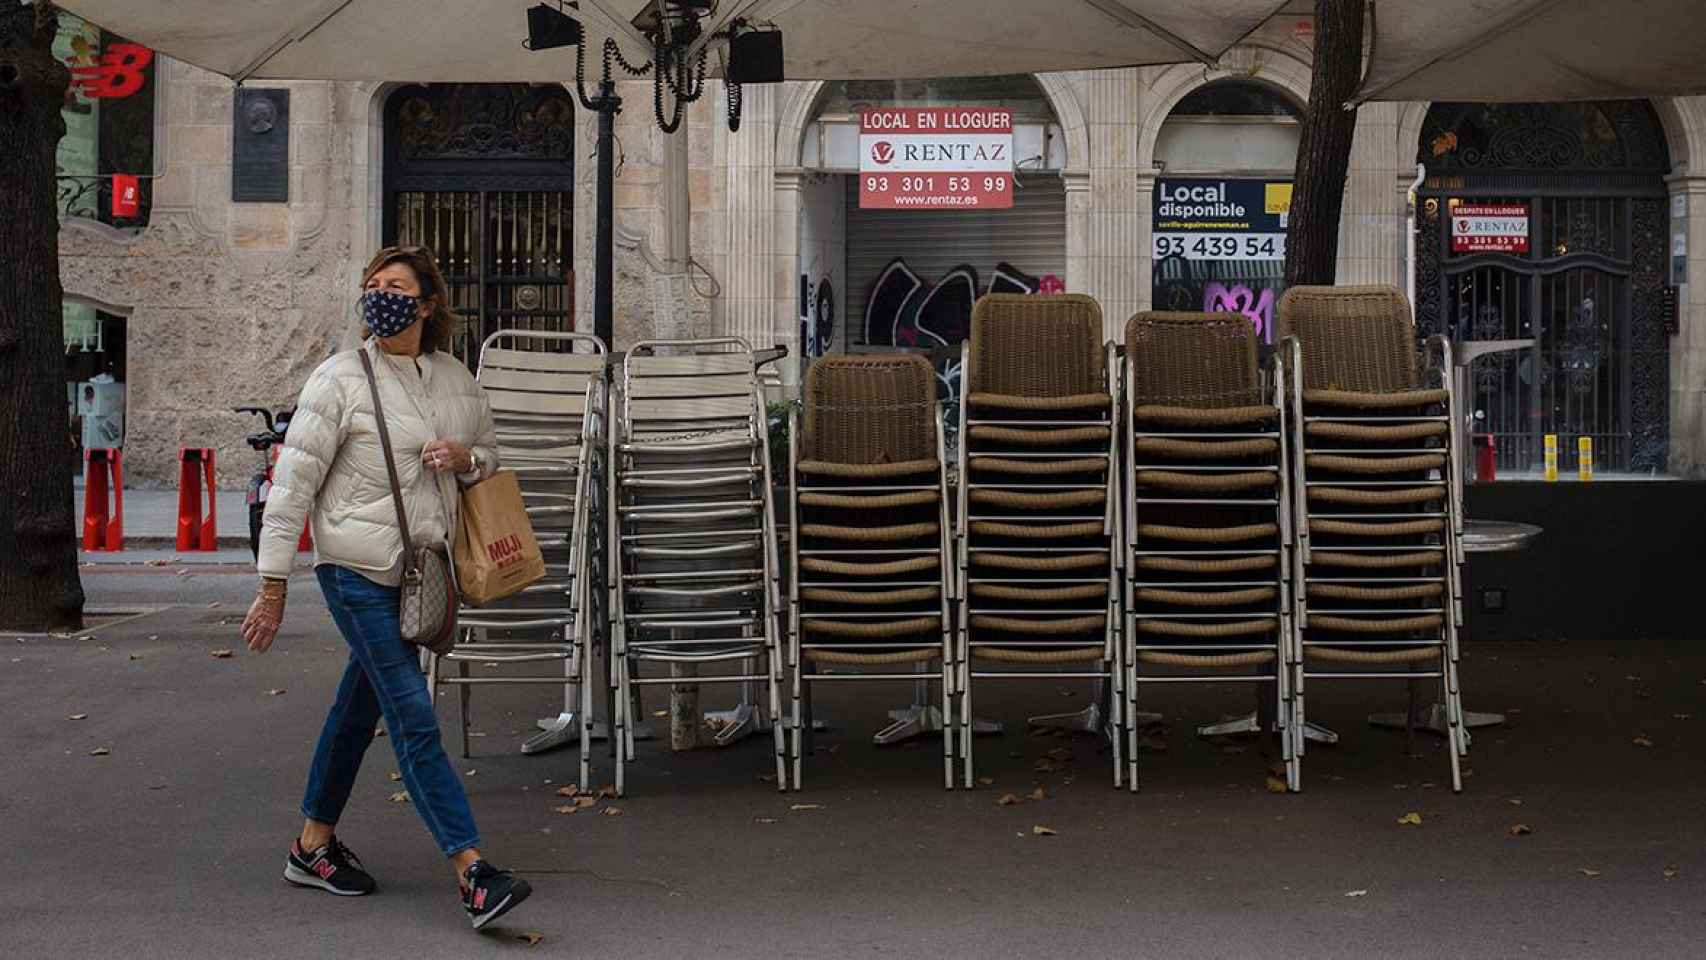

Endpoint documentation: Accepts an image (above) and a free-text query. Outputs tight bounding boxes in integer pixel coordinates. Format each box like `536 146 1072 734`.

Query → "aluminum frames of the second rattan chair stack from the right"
1121 325 1302 793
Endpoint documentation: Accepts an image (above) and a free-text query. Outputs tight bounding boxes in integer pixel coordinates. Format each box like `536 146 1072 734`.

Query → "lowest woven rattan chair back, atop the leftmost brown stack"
800 355 937 464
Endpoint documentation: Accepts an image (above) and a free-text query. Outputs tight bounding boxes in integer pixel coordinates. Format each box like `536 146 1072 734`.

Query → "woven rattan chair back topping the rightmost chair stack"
1278 285 1419 394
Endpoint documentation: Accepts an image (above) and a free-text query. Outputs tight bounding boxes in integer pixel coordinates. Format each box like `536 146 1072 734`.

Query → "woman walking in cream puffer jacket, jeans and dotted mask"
242 247 532 929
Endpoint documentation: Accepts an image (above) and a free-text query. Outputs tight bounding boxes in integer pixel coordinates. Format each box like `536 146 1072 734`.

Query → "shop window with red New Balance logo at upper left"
53 12 159 228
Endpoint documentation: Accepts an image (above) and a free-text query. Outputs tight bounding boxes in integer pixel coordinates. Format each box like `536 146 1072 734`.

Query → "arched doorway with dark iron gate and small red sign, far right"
1416 101 1670 474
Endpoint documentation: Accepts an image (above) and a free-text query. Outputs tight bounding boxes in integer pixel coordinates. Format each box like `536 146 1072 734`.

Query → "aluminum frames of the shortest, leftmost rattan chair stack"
788 364 959 789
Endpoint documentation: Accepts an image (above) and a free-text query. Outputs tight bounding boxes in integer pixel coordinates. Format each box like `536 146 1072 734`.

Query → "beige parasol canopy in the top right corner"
1358 0 1706 101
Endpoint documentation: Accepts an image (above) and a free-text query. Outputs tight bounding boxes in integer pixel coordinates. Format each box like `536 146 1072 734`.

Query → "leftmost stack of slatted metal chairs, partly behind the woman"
428 331 607 789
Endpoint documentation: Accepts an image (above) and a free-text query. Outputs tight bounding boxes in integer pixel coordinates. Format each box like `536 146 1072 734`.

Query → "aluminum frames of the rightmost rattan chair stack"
1281 336 1469 793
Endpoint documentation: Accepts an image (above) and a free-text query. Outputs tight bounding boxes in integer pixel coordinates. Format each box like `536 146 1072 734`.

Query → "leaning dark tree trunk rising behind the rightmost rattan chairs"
1285 0 1365 286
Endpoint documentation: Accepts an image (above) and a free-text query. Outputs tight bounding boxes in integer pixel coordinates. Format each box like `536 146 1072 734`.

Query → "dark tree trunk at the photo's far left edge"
0 0 84 629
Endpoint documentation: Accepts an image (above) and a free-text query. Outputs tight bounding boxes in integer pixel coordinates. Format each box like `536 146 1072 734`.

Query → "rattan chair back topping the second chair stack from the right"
1126 310 1262 408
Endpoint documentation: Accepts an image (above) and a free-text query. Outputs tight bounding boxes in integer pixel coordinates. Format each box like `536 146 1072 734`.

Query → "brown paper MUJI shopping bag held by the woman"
456 471 544 607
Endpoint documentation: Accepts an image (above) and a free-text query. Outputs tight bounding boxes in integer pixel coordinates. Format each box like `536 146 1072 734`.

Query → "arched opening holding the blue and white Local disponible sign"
1150 78 1302 343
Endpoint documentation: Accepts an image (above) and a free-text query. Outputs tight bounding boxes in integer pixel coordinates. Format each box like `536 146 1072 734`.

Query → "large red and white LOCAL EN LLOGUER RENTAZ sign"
858 107 1013 210
